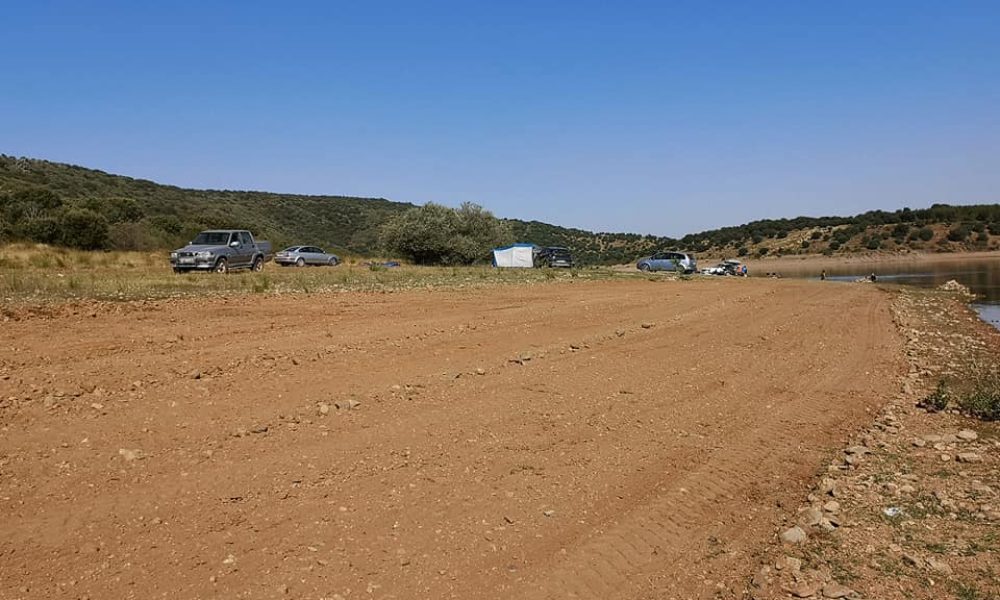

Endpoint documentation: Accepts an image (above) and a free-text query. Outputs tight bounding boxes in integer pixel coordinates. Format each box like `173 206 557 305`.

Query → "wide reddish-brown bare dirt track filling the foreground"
0 279 905 600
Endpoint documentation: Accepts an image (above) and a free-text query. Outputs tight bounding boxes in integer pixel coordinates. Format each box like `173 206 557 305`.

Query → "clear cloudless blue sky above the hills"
0 0 1000 236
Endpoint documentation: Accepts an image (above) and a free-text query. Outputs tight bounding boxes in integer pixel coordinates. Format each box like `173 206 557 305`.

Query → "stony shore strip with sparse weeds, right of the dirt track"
745 285 1000 600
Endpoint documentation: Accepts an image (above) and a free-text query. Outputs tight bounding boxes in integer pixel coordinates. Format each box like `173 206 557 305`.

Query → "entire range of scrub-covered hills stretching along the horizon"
0 155 1000 264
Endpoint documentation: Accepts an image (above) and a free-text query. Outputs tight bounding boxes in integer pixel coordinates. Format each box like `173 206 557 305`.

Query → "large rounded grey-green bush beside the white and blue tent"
379 202 511 265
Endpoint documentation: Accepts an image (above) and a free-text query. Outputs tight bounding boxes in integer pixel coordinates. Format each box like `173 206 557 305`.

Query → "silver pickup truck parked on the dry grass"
170 229 271 273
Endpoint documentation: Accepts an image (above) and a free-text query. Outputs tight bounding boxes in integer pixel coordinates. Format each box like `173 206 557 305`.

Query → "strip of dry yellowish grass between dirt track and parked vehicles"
0 244 656 303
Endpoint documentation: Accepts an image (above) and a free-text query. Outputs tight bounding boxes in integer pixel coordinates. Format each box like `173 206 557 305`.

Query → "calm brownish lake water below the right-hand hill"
758 253 1000 329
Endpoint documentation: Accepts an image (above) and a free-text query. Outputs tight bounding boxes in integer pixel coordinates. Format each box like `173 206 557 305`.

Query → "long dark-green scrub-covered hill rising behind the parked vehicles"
0 155 676 264
